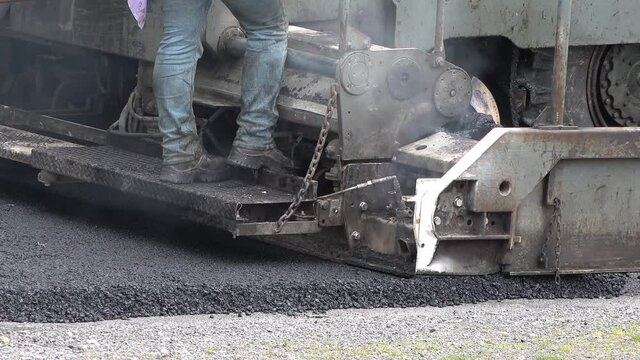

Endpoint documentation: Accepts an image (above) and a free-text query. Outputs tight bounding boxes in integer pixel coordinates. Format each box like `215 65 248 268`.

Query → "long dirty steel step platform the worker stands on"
0 126 320 236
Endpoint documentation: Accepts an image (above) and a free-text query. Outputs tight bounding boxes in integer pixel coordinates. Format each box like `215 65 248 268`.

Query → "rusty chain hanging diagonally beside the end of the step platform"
274 83 339 233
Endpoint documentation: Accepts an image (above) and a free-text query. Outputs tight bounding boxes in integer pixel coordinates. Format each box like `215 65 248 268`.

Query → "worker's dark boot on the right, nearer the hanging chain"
227 146 295 174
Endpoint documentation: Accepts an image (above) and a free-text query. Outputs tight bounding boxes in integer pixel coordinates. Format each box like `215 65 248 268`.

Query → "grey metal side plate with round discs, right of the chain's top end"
339 48 470 161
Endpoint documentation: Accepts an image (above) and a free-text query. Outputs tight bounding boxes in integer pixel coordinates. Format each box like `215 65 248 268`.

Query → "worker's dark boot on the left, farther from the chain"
160 154 231 184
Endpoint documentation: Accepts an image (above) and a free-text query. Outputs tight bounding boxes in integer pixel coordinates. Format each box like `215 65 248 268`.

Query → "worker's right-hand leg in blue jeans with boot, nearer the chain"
224 0 291 172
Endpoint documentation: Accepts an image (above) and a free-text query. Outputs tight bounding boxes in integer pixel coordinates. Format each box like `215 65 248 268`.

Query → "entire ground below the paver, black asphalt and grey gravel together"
0 163 640 360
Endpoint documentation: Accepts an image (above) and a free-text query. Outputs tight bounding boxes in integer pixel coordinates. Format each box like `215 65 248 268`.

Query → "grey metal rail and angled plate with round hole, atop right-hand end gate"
461 128 640 212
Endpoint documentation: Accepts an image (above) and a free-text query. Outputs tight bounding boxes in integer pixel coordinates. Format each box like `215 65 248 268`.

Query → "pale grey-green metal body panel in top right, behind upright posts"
395 0 640 49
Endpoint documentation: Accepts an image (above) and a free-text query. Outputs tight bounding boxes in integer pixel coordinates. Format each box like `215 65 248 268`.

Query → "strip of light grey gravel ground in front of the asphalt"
0 296 640 360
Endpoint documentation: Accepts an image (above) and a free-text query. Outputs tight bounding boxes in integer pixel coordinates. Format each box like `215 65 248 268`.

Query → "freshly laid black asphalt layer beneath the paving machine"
0 163 627 322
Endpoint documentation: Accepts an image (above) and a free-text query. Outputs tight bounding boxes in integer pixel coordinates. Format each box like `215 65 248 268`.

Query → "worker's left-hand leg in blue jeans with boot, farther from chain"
153 0 228 183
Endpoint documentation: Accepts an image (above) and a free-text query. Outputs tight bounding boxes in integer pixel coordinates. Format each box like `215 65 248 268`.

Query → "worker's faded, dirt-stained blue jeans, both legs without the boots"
153 0 288 165
